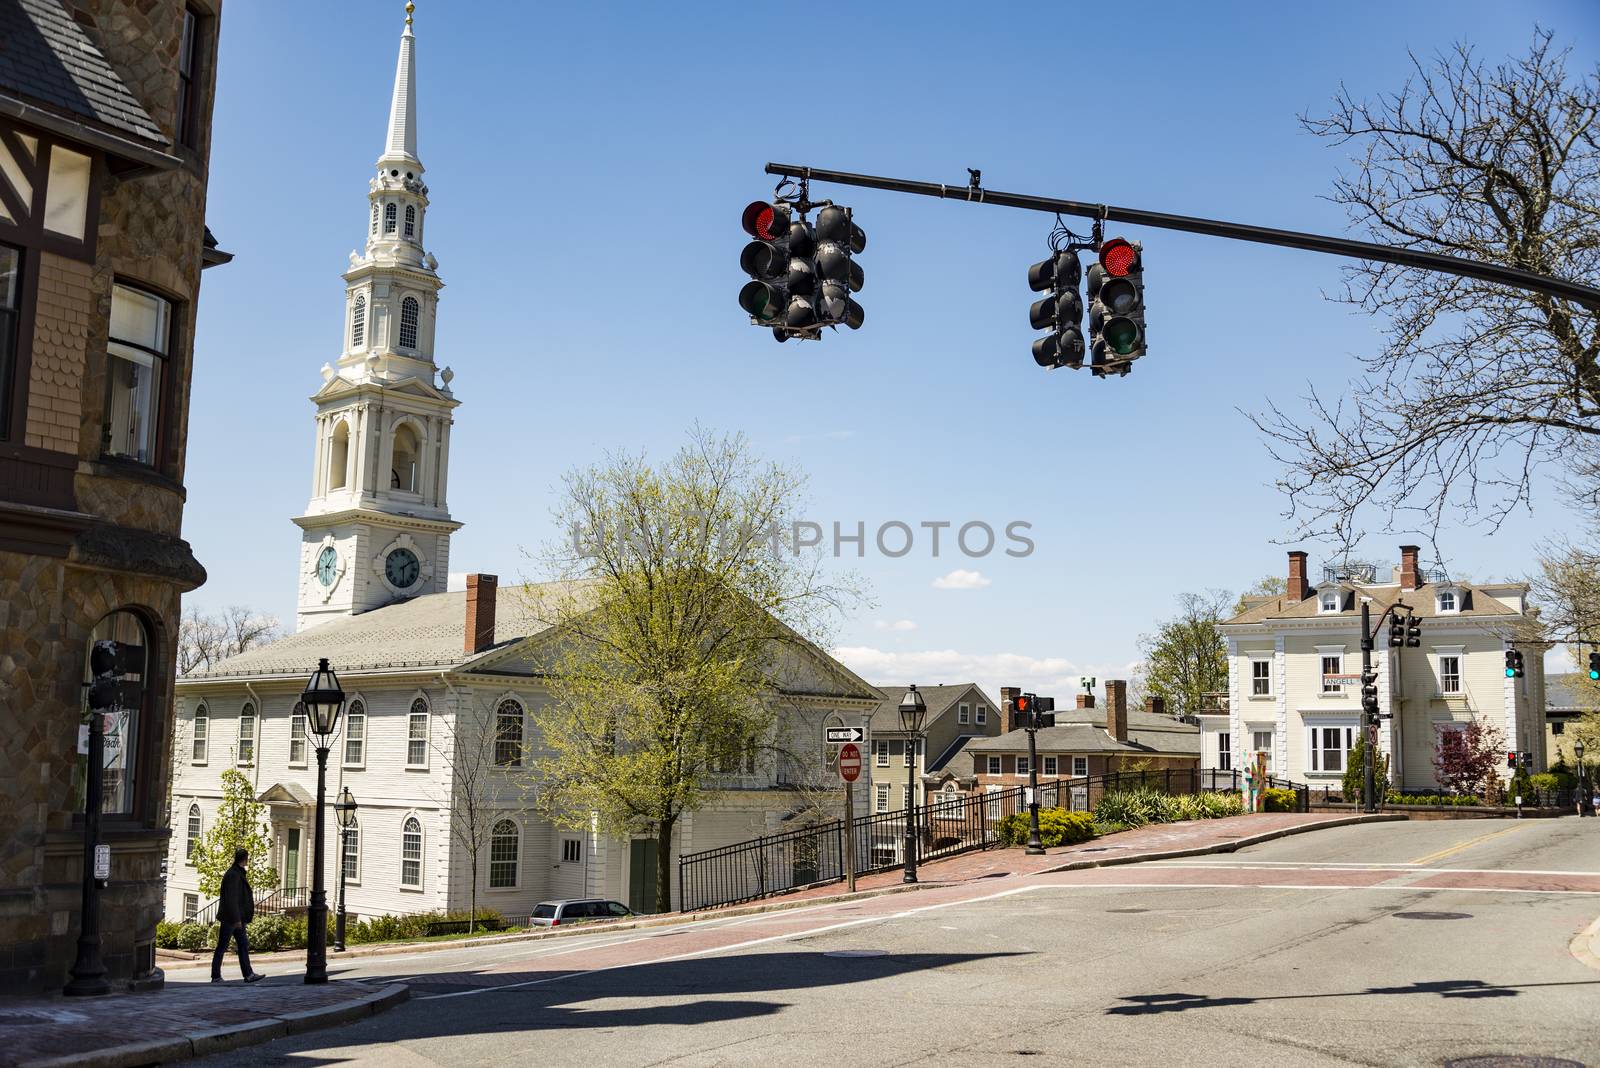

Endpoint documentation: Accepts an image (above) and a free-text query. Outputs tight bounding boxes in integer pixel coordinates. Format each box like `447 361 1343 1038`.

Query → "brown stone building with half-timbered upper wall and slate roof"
0 0 229 991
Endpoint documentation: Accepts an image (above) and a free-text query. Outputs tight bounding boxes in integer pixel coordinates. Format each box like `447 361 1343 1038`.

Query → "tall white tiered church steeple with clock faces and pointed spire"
294 3 461 628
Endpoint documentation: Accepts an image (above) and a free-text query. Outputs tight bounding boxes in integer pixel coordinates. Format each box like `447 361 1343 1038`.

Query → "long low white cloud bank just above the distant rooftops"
834 646 1138 705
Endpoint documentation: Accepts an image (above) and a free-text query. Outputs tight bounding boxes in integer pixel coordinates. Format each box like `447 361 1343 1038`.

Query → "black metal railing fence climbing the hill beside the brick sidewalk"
678 767 1307 911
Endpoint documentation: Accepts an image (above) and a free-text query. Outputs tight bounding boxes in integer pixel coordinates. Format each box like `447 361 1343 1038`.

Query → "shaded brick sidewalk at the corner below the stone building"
0 978 406 1068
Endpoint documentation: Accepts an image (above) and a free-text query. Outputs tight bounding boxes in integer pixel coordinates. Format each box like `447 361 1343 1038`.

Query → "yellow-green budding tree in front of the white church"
530 428 858 911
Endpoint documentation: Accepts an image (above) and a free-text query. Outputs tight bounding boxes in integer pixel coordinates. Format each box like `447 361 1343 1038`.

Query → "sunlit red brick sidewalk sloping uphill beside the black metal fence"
726 812 1405 911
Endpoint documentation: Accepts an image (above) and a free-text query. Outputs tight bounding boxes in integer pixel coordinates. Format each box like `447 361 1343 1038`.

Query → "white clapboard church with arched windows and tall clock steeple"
166 10 880 919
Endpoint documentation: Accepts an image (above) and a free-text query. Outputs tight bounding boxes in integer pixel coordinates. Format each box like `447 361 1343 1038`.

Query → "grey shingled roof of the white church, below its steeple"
184 582 578 681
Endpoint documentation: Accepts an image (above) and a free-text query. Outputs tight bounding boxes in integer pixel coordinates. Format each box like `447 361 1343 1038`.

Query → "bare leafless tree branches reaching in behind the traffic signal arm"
1253 29 1600 547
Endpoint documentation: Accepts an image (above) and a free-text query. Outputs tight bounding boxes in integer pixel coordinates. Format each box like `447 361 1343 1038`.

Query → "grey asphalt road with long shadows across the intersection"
170 819 1600 1068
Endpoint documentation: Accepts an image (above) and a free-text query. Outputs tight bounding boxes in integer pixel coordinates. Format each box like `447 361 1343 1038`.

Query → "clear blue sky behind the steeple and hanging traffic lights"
186 0 1600 692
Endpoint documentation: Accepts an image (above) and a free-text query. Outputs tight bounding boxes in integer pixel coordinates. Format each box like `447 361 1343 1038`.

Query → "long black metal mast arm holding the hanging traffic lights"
766 163 1600 312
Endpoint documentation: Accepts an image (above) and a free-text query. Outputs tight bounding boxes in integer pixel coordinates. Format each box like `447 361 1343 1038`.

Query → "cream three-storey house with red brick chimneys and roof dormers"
1200 545 1546 790
